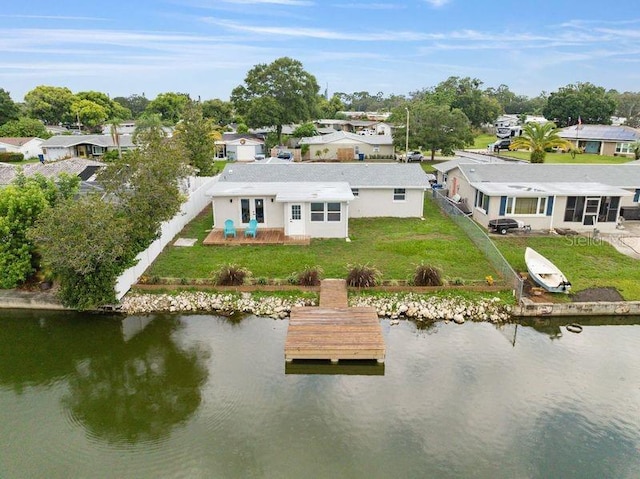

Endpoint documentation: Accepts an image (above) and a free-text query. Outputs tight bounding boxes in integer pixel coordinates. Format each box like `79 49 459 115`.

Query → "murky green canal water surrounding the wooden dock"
0 311 640 479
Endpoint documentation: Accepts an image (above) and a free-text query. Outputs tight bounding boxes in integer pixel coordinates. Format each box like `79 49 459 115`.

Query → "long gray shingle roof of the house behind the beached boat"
458 163 640 188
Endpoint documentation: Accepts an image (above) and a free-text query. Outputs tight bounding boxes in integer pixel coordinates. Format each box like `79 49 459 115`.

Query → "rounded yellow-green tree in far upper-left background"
24 85 74 125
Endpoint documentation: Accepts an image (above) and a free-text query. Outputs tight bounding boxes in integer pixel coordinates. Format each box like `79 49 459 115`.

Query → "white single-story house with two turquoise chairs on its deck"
207 163 433 238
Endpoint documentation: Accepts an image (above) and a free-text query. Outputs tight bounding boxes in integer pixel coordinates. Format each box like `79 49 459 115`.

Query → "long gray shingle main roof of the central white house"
214 163 435 189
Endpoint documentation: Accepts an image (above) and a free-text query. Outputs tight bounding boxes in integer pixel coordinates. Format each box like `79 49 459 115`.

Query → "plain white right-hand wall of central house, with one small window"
349 188 424 218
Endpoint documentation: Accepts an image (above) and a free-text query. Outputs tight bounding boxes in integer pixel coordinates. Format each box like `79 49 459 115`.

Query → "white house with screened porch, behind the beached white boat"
446 163 640 232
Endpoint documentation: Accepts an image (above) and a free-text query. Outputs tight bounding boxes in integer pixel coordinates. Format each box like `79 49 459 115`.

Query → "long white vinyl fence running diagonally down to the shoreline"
115 176 217 300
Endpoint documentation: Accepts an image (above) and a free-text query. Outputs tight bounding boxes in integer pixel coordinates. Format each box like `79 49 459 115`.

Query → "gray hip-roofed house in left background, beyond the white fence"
42 135 136 161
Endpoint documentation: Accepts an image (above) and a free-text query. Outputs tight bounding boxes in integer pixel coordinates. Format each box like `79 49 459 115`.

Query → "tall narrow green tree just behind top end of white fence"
174 102 220 176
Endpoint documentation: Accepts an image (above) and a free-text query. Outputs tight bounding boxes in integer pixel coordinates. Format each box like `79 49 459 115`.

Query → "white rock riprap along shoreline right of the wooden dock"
349 293 511 324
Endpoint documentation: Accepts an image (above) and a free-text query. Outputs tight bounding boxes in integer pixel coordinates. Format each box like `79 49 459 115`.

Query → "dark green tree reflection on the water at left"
0 314 208 444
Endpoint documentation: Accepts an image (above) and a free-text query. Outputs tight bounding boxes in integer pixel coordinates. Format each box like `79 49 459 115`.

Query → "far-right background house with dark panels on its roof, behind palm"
558 125 640 156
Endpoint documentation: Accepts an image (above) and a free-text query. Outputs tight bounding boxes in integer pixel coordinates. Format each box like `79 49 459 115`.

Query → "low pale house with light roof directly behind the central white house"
300 131 395 161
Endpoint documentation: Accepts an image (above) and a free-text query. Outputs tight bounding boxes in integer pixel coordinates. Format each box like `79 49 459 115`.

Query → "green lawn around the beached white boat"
495 236 640 301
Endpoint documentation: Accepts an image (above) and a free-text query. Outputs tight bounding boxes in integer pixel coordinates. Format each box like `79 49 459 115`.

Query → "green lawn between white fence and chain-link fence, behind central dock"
146 199 496 284
